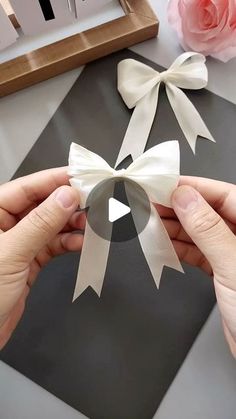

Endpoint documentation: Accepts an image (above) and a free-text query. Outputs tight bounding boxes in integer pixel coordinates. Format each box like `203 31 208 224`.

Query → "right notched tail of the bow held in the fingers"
134 204 184 288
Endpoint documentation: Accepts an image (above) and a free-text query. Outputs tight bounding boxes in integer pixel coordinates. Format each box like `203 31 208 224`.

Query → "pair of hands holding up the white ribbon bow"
0 168 236 357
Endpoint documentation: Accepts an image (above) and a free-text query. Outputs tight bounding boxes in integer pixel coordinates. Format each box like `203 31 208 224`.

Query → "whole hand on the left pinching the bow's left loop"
0 168 84 349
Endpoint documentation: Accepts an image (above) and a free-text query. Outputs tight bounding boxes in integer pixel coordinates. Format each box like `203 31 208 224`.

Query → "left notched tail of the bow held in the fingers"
73 222 110 302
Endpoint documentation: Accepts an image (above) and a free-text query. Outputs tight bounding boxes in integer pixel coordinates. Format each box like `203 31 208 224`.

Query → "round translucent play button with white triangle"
86 177 151 242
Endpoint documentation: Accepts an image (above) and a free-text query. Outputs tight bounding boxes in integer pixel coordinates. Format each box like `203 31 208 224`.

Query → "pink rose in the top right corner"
168 0 236 62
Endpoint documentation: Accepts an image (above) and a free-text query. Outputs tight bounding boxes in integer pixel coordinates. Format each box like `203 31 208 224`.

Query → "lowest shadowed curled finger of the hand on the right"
172 240 212 276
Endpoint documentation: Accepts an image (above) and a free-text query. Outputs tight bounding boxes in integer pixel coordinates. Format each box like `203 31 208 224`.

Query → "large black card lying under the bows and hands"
1 51 236 419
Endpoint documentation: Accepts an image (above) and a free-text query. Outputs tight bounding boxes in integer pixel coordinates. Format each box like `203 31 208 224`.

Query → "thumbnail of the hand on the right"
173 186 198 211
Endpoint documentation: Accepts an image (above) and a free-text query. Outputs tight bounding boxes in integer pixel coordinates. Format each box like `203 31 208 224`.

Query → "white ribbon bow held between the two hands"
68 141 183 301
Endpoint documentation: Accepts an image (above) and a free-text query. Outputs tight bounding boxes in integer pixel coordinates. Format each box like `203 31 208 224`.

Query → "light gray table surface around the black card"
0 0 236 419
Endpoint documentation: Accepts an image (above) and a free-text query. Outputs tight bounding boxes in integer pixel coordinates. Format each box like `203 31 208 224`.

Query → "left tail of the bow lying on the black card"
115 83 160 167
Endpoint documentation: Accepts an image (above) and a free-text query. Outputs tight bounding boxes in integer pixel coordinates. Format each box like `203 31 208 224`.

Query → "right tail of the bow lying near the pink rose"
166 83 215 153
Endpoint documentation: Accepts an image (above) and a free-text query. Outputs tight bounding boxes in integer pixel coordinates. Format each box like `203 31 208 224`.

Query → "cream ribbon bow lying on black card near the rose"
116 52 215 166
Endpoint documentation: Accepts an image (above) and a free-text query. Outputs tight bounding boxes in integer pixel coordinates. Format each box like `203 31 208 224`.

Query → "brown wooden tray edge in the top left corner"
0 0 159 97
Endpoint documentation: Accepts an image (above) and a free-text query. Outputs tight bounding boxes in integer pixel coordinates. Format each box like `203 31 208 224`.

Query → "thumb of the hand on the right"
172 186 236 289
